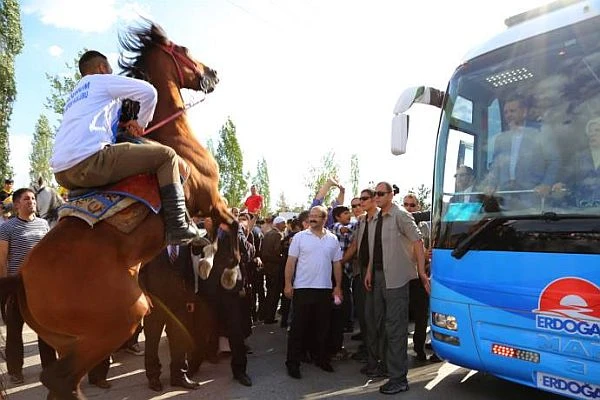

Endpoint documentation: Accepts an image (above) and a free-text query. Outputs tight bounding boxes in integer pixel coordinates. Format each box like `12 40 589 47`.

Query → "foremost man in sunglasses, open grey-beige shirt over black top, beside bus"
365 182 429 394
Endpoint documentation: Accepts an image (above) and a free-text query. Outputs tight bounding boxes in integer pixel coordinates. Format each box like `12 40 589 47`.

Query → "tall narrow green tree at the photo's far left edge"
0 0 23 178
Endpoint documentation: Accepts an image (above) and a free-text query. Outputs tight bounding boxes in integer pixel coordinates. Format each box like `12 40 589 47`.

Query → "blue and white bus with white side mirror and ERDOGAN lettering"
392 0 600 399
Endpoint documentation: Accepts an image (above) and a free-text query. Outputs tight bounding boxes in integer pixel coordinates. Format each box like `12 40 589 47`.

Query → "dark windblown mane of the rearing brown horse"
119 19 169 80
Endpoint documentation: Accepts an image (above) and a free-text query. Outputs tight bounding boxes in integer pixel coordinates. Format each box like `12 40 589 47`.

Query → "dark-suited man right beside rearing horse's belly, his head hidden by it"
139 245 200 392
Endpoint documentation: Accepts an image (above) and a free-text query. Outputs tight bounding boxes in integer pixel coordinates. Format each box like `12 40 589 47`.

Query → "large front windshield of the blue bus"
434 18 600 253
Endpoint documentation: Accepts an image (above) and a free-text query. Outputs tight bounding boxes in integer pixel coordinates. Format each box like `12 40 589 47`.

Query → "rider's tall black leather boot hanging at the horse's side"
160 183 200 244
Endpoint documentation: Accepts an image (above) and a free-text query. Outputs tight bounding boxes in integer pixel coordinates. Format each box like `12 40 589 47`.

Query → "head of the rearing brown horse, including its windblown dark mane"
119 21 219 93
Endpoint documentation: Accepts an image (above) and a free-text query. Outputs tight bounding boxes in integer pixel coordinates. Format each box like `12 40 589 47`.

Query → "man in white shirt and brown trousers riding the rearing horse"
50 50 199 244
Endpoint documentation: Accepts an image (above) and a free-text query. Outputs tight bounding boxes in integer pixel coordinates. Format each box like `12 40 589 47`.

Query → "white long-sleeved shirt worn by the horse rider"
50 74 157 172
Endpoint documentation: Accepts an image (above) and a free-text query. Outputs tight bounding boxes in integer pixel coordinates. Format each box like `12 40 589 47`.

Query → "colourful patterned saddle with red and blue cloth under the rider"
58 174 161 233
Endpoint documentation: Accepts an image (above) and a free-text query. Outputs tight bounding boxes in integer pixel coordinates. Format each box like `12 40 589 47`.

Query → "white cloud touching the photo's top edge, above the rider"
23 0 149 33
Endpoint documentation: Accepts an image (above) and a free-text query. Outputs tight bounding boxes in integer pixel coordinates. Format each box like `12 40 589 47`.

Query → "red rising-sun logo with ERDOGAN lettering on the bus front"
532 277 600 338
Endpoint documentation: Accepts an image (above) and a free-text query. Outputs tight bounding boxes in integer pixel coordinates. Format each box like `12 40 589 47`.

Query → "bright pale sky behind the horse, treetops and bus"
10 0 545 204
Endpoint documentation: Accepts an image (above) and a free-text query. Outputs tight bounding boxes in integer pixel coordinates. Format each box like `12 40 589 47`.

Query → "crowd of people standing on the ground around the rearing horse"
0 179 438 393
